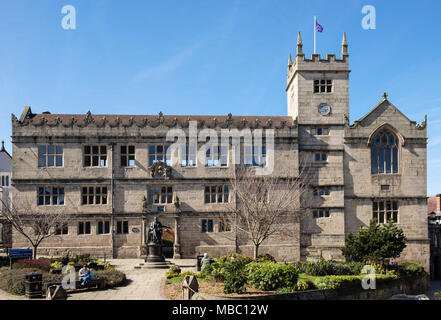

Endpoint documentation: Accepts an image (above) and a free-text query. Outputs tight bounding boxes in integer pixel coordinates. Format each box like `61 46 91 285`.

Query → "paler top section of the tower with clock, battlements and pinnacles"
286 33 350 125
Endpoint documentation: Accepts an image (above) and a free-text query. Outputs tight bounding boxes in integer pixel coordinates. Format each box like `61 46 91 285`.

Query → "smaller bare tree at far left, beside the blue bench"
0 197 70 259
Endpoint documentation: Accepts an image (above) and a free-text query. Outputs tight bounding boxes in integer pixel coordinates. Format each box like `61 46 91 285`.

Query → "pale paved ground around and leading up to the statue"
0 259 196 300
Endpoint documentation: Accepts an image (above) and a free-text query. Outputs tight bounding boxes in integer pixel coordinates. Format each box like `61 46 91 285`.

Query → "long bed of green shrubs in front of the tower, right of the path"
166 254 425 298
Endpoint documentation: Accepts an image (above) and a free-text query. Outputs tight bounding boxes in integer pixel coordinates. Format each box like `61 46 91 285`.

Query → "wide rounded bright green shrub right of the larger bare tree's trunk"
247 262 299 291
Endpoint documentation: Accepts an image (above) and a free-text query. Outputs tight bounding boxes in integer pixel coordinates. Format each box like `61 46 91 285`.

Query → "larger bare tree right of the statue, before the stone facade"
223 168 313 258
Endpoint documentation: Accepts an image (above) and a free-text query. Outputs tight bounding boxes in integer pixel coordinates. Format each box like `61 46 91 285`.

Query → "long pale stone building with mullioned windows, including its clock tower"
12 34 429 269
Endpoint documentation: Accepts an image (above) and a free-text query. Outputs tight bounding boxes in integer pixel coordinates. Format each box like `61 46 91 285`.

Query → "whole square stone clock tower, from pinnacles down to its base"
286 33 350 259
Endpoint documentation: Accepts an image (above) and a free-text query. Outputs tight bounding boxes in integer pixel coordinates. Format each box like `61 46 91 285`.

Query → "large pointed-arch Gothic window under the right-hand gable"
371 129 398 174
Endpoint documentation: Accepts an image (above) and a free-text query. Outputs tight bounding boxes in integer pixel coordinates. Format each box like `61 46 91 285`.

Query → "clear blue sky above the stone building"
0 0 441 194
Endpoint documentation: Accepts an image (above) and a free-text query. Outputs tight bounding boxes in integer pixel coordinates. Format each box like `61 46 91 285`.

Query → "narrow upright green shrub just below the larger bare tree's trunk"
224 258 247 293
